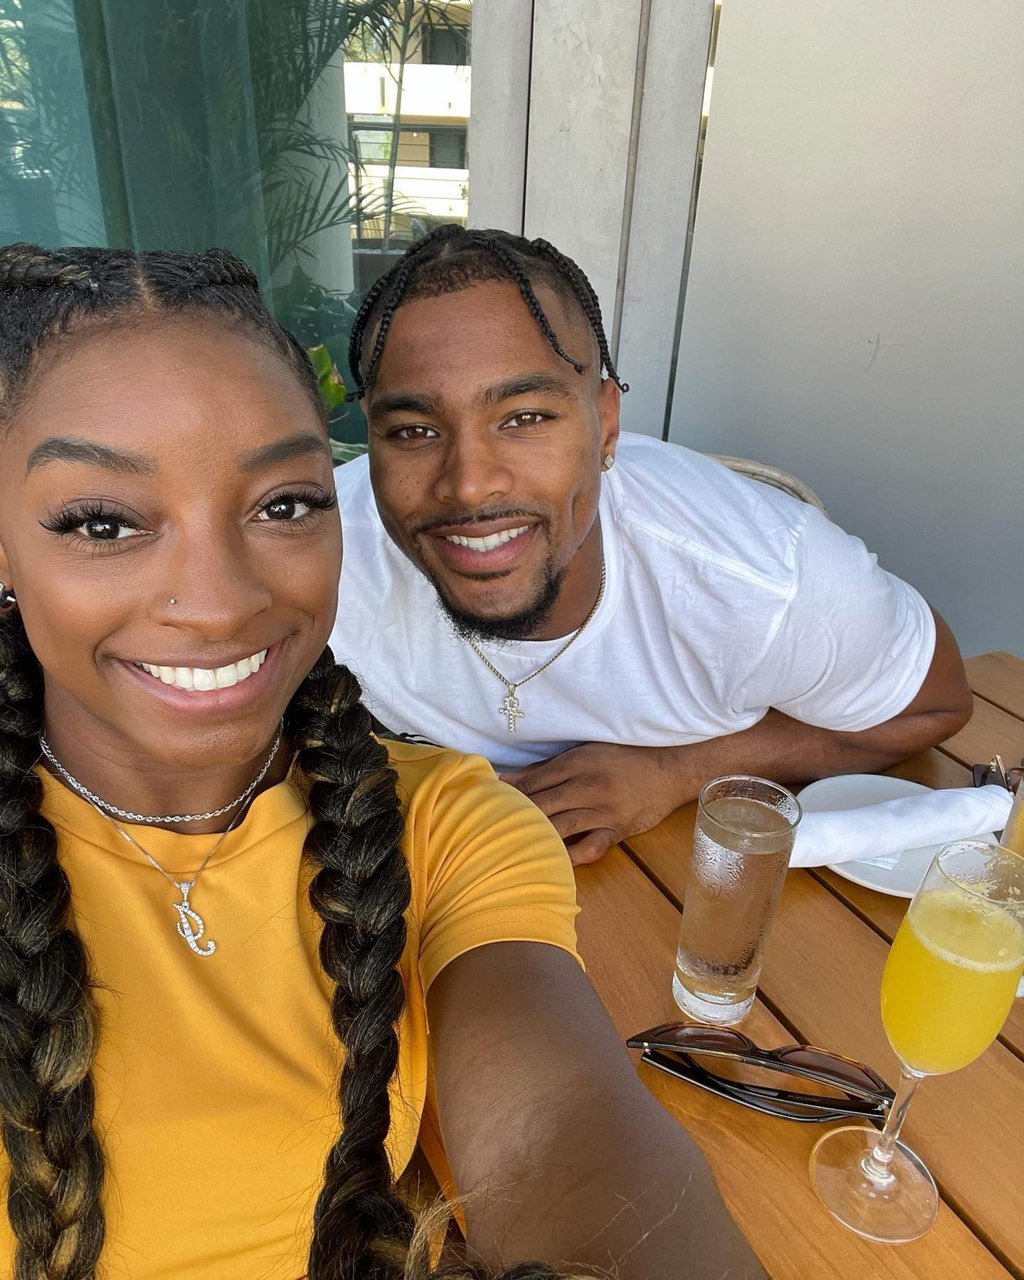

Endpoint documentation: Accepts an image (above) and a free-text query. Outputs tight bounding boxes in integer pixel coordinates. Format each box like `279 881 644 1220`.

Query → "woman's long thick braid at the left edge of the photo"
0 611 104 1280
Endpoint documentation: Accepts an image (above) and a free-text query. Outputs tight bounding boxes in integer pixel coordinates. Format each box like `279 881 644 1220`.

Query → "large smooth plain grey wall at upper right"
671 0 1024 654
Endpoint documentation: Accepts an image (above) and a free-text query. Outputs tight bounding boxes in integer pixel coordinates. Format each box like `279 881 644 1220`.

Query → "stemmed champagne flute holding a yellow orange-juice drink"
810 840 1024 1244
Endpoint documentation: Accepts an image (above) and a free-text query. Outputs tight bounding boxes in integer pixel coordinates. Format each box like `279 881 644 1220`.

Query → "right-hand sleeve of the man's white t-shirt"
744 508 936 732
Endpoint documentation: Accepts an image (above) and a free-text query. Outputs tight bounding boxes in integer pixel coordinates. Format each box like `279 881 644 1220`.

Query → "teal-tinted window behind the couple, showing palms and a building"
0 0 472 440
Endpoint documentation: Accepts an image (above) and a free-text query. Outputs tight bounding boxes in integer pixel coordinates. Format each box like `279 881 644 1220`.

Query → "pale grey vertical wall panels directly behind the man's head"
470 0 713 435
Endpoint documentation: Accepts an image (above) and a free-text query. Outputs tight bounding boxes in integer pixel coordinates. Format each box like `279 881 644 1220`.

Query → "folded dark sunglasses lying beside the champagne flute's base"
626 1023 893 1124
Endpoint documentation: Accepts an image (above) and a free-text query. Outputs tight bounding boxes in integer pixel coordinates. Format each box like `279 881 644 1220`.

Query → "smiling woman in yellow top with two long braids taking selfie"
0 244 762 1280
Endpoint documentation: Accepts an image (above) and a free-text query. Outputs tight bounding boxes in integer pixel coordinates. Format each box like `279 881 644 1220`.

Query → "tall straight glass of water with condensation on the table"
672 774 800 1027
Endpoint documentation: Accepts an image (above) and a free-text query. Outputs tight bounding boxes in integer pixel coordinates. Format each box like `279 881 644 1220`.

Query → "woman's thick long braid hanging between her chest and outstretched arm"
285 650 412 1280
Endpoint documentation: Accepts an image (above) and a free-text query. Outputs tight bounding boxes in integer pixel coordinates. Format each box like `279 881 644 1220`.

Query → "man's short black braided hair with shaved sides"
348 223 630 399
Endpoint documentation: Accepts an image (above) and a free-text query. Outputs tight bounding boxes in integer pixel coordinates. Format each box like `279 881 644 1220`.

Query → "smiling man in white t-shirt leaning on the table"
332 228 970 861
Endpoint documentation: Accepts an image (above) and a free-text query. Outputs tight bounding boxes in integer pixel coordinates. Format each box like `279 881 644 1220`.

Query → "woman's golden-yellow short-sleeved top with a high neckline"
0 742 576 1280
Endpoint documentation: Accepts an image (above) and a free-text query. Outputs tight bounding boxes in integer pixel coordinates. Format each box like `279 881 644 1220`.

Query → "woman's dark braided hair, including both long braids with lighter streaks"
0 244 596 1280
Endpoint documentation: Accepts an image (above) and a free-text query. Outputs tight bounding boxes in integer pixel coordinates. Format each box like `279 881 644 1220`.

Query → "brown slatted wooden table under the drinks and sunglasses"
577 653 1024 1280
